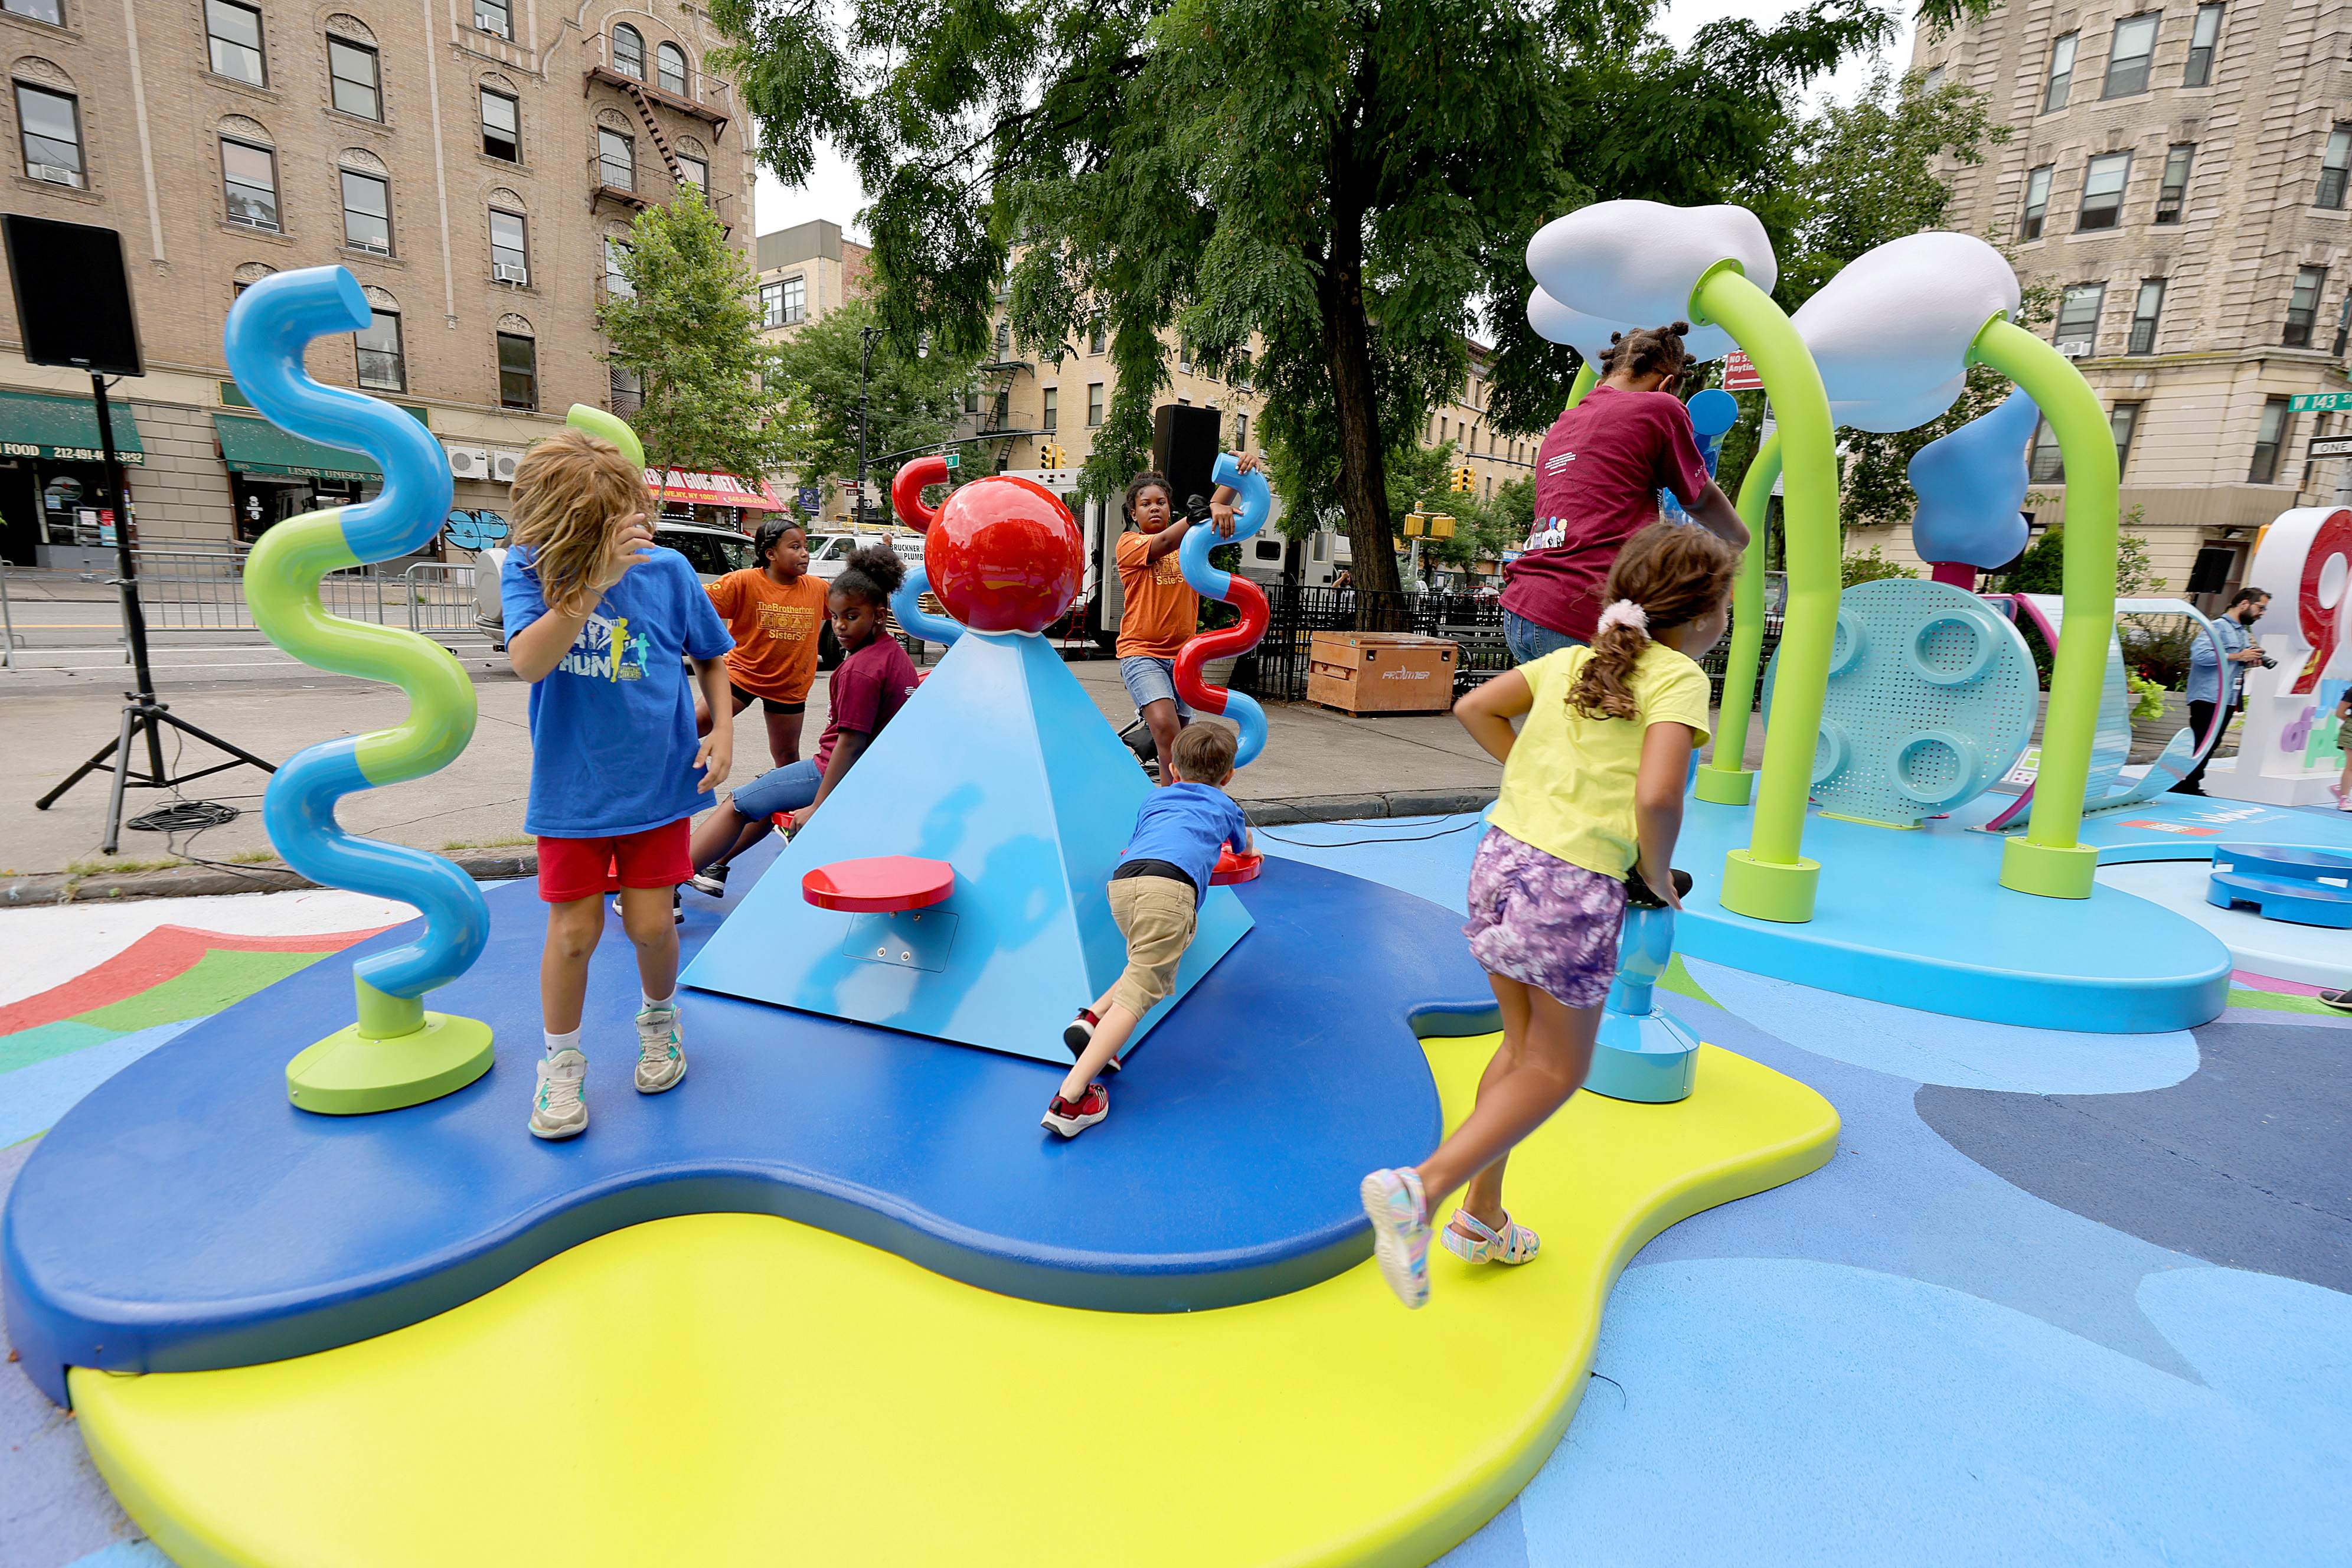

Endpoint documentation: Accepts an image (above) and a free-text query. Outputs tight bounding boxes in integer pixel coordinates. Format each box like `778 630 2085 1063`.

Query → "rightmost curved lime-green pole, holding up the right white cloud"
1969 318 2119 898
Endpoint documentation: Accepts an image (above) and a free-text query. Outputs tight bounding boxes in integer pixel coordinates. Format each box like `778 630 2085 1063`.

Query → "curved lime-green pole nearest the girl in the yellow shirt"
1691 261 1839 924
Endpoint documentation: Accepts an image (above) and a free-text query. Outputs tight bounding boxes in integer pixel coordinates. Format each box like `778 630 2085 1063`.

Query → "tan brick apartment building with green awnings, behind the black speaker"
0 0 753 564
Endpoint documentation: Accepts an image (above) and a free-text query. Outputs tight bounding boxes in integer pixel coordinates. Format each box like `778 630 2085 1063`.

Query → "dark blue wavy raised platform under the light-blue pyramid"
0 851 1491 1403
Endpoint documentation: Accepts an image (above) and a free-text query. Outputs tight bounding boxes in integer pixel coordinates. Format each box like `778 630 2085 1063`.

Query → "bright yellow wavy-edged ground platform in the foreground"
71 1037 1837 1568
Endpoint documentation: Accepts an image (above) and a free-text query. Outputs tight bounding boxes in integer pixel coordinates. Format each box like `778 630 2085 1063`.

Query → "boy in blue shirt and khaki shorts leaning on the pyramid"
1044 724 1249 1138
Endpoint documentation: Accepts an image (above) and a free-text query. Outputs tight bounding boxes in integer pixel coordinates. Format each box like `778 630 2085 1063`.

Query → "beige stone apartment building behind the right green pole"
1900 0 2352 606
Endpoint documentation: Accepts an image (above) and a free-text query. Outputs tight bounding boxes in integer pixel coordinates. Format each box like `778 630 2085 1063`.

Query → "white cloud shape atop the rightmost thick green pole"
1795 230 2018 430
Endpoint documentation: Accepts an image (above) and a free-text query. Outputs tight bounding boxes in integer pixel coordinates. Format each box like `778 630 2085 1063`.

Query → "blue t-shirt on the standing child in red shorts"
499 545 734 839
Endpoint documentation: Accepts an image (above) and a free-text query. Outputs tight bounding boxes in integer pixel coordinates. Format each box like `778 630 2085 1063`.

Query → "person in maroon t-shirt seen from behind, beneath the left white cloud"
1503 322 1747 663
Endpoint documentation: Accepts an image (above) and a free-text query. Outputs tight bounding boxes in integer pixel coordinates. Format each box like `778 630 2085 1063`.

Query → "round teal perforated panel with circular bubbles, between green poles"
1764 579 2041 828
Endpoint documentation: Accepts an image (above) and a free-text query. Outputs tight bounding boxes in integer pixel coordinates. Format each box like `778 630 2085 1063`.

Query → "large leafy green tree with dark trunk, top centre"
713 0 1990 588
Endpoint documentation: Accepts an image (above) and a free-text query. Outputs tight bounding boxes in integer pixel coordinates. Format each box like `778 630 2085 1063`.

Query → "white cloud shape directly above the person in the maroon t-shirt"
1527 202 1781 329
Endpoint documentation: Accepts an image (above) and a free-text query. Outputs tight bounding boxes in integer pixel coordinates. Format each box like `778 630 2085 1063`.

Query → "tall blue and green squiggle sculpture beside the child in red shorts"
223 268 492 1114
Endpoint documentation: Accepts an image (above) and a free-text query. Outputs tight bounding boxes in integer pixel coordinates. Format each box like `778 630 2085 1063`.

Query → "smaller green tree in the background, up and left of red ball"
776 299 978 496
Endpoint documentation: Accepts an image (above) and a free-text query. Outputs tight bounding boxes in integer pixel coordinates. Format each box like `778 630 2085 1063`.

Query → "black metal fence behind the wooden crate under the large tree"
1233 583 1781 705
